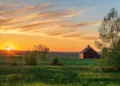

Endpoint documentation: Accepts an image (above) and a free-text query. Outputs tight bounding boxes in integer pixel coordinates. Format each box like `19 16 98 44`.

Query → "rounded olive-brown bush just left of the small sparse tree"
24 51 37 65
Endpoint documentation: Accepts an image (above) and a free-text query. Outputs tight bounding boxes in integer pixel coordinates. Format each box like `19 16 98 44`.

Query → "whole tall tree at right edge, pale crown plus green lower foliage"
95 8 120 68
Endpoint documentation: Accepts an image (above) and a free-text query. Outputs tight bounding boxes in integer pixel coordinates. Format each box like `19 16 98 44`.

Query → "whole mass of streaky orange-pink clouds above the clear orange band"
0 0 100 39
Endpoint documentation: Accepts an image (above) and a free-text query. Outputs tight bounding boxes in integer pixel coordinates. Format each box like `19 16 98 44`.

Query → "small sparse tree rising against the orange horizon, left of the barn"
35 44 49 58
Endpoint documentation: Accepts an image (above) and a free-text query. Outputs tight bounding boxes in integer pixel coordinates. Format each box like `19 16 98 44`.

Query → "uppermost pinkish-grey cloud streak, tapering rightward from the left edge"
0 4 53 17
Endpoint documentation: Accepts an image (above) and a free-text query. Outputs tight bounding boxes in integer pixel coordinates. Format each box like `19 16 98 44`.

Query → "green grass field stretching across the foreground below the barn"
0 58 120 86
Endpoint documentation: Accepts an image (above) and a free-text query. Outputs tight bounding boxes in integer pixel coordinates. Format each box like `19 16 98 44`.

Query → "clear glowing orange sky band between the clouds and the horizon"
0 34 99 52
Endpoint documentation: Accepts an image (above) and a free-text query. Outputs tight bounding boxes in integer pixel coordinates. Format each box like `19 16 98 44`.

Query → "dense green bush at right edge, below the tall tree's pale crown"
102 40 120 71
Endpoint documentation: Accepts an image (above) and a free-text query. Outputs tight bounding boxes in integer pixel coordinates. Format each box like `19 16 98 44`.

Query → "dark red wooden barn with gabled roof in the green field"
79 45 99 59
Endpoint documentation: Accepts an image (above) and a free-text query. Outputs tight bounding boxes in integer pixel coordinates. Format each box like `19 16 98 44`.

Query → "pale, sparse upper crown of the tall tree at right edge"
95 8 120 49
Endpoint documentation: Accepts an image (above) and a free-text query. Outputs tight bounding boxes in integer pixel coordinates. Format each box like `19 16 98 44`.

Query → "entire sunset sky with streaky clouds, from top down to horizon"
0 0 120 52
